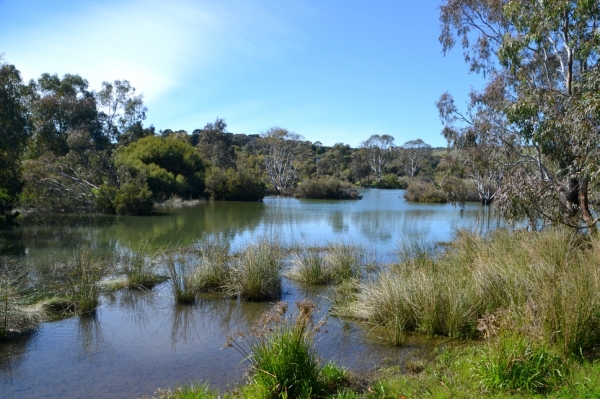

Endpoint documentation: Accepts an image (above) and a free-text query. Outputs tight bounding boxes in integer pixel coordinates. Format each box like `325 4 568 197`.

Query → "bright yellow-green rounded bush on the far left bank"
115 136 204 199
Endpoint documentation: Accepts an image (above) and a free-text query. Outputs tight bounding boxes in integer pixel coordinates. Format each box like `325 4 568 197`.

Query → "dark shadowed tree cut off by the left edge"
0 57 31 218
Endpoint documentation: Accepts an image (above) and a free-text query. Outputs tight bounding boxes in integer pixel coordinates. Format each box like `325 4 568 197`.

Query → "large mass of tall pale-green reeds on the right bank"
352 229 600 356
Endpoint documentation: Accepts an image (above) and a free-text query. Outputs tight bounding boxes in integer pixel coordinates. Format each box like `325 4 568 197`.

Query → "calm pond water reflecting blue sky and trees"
0 190 501 398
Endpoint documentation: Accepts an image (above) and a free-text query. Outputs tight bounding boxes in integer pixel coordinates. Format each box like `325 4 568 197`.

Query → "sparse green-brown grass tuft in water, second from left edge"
53 245 108 315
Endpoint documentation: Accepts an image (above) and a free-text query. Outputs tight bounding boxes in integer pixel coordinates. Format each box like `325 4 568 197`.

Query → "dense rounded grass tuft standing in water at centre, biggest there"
224 239 283 301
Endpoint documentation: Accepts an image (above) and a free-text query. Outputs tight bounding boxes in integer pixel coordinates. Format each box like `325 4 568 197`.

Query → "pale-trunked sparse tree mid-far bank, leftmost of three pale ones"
261 127 303 195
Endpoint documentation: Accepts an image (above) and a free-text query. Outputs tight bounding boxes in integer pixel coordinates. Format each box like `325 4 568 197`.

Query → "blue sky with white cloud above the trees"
0 0 483 147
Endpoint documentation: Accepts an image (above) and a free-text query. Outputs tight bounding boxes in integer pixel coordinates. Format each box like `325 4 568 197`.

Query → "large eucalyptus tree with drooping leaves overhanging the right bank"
438 0 600 229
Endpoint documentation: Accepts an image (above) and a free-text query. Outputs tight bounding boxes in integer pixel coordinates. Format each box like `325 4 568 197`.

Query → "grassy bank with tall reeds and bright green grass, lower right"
145 230 600 398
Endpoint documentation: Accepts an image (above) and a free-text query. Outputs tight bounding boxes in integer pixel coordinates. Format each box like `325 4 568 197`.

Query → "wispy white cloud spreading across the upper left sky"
0 0 304 102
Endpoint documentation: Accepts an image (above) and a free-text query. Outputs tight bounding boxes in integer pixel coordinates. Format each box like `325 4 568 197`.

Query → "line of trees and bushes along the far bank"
0 57 446 220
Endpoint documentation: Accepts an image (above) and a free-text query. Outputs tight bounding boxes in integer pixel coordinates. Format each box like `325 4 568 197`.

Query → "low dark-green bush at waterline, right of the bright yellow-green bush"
206 167 265 201
